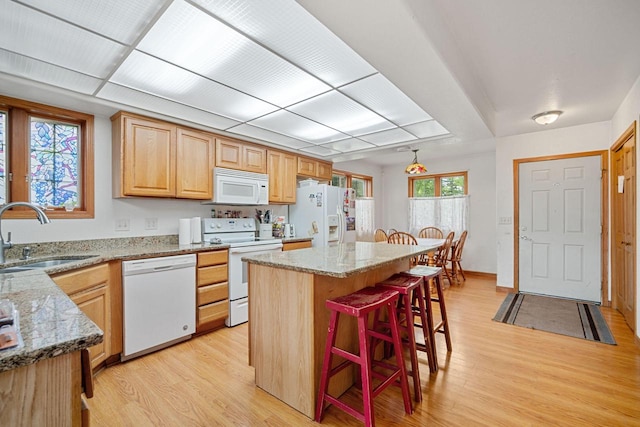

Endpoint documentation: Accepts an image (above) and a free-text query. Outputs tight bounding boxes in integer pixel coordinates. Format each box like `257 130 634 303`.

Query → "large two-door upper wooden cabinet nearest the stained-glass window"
111 112 214 200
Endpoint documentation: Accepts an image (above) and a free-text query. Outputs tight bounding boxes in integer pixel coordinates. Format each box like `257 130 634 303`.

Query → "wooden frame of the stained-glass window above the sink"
0 95 95 219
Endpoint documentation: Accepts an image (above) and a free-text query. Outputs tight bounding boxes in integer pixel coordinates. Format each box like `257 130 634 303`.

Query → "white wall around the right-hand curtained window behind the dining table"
379 152 497 273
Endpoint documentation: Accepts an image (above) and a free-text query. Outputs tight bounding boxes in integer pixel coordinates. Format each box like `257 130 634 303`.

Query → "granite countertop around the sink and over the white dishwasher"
0 236 229 372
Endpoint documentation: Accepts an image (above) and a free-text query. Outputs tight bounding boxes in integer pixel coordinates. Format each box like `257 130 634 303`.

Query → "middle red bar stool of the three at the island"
374 274 433 402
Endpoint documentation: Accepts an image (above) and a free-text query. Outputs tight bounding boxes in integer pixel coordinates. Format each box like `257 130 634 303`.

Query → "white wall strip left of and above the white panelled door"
496 122 612 288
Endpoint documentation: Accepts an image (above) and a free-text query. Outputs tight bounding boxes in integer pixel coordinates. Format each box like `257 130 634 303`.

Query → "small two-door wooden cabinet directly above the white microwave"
216 138 267 173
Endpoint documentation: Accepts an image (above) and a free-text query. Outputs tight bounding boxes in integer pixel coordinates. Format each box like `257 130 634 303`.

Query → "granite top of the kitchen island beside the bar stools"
242 242 433 278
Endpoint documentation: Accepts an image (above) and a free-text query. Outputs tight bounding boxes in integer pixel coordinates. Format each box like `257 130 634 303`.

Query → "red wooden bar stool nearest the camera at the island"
315 287 413 426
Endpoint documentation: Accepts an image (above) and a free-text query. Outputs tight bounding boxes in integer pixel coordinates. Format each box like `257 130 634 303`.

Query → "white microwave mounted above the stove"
213 168 269 205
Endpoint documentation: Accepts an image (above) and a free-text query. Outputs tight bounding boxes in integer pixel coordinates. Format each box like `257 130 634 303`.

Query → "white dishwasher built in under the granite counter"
121 254 196 361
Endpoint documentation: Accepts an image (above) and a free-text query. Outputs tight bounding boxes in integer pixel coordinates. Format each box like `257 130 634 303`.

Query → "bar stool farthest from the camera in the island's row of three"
402 265 452 370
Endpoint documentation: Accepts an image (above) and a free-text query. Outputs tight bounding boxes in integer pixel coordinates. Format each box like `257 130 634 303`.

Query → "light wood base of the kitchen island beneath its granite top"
249 261 409 418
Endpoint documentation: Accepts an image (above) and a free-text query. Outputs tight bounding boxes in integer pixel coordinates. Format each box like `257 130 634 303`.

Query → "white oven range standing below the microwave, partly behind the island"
202 218 282 327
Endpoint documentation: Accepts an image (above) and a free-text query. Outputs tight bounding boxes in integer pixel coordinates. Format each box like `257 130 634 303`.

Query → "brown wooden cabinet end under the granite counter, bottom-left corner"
0 351 82 426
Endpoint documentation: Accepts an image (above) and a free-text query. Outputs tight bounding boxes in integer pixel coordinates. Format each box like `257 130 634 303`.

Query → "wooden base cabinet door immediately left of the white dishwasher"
69 284 111 369
